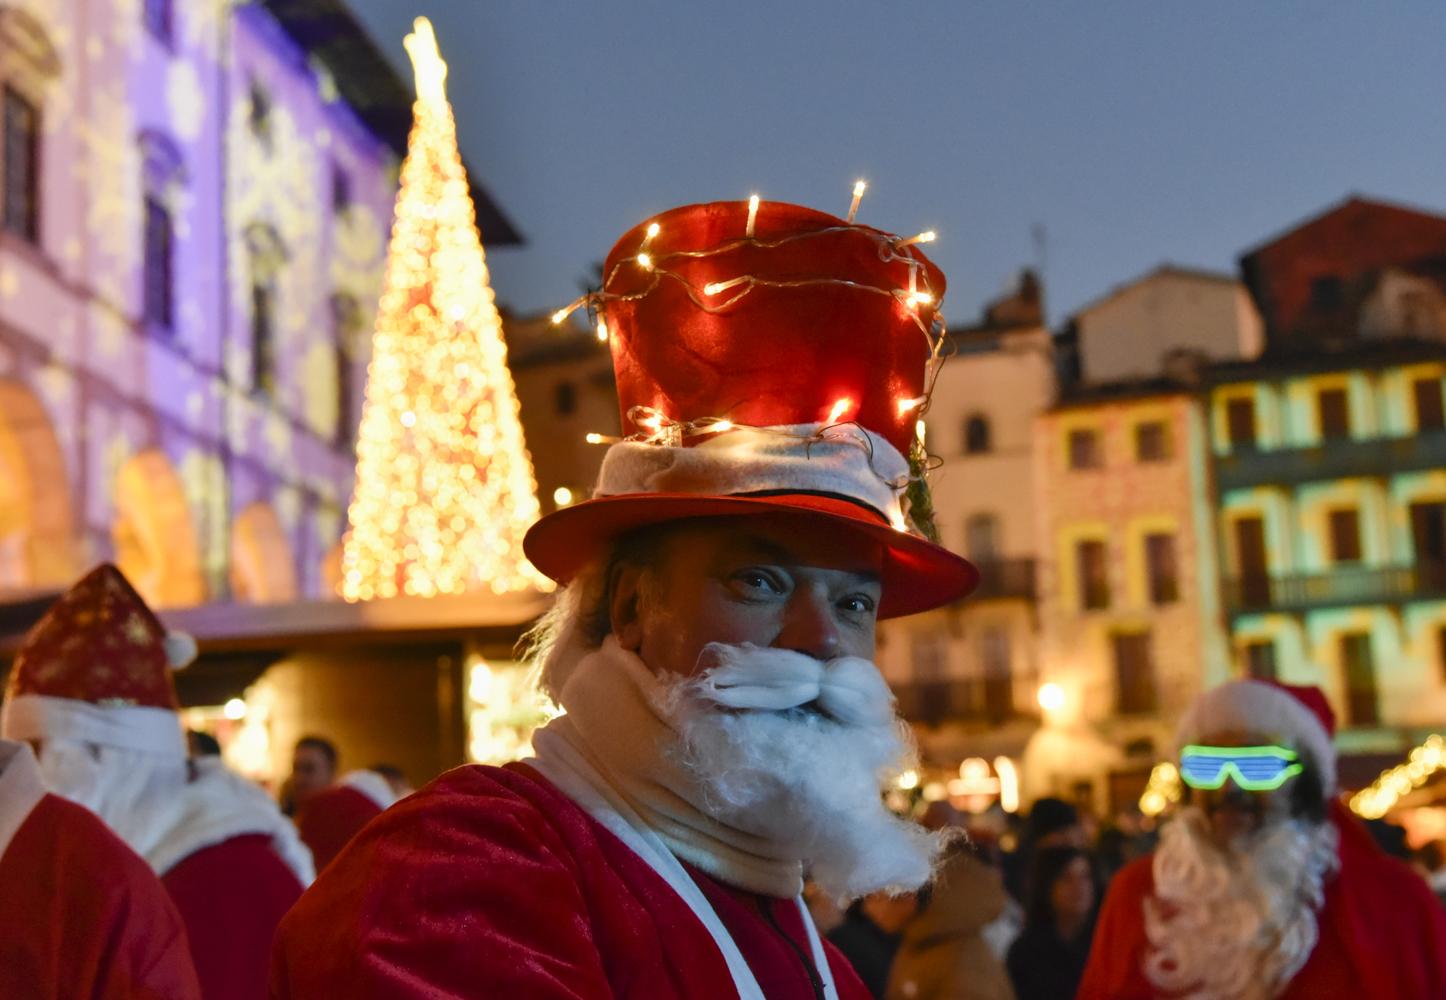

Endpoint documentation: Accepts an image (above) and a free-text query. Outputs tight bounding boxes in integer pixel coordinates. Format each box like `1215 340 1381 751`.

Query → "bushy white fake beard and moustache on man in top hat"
658 643 943 900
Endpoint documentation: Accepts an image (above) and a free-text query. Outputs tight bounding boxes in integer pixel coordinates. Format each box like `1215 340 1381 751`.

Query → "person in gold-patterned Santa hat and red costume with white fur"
0 565 312 1000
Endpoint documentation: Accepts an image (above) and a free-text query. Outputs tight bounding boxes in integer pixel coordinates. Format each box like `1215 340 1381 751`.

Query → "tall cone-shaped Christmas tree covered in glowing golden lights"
341 17 549 600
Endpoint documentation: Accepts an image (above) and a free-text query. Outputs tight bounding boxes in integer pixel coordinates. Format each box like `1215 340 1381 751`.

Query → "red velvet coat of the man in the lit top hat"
272 764 869 1000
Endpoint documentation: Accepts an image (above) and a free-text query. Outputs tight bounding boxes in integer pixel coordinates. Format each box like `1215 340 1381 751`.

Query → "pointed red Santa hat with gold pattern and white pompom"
0 564 197 757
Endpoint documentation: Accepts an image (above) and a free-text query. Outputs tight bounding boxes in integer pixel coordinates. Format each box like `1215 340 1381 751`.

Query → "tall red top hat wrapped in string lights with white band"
523 202 977 617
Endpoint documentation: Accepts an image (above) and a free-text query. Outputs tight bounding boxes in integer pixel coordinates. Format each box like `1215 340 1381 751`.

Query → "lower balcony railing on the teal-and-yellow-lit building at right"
1225 562 1446 616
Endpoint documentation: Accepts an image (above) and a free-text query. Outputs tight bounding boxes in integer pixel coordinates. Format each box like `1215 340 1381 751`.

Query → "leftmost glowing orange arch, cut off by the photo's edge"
0 379 78 590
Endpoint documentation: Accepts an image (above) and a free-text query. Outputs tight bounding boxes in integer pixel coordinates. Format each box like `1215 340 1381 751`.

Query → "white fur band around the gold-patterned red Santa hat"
0 695 187 760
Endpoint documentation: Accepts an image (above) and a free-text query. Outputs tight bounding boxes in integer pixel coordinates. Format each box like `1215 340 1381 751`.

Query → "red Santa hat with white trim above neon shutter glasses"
1176 681 1336 798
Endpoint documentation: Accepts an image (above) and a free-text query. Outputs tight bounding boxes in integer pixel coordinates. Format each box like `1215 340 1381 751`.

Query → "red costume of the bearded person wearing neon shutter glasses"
1079 806 1446 1000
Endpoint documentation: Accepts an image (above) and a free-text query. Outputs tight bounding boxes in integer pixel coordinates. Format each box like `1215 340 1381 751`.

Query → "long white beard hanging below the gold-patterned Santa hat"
39 740 187 857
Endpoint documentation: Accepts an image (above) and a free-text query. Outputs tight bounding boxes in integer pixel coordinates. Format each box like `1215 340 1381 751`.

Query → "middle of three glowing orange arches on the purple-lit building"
111 448 205 607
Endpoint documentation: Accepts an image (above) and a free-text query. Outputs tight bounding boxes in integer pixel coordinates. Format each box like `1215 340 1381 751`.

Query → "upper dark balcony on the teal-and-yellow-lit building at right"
1215 431 1446 491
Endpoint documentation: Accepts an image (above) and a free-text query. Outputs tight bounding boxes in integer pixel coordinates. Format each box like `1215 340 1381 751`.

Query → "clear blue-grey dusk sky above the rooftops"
348 0 1446 324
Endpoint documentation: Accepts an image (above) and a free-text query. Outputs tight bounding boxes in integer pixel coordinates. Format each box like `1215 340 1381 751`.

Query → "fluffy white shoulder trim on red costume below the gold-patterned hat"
142 757 317 886
